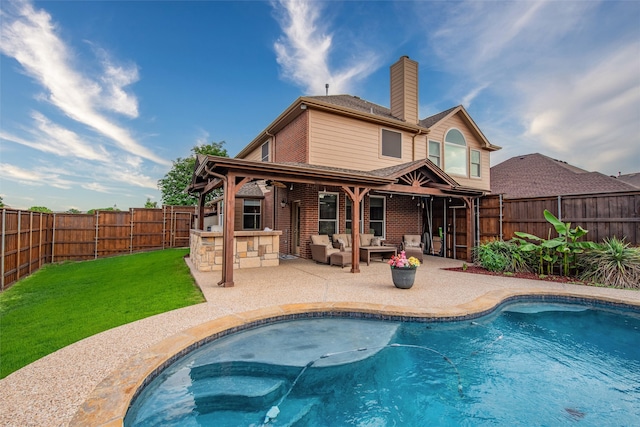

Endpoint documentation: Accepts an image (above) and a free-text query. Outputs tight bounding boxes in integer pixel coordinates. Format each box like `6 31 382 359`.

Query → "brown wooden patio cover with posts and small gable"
187 155 483 287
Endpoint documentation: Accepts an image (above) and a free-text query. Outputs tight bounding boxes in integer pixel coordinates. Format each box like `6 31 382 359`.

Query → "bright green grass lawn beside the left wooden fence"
0 249 204 378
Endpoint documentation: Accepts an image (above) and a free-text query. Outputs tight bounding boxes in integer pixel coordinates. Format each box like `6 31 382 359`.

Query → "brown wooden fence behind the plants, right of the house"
478 191 640 246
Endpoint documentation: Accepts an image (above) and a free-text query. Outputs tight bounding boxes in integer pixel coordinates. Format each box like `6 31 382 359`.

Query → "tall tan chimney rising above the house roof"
391 55 418 124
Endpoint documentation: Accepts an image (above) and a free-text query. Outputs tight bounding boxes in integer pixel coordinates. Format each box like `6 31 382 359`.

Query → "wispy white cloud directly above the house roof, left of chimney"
274 0 378 95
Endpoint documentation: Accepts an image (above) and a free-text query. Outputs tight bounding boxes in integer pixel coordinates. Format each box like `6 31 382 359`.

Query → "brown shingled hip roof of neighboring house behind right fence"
491 153 637 199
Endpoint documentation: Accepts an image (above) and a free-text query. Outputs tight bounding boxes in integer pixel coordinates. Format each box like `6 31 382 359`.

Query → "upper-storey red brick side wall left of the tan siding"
273 111 309 163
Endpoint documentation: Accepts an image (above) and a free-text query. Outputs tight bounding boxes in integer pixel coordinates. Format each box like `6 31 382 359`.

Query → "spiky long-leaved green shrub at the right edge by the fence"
579 237 640 289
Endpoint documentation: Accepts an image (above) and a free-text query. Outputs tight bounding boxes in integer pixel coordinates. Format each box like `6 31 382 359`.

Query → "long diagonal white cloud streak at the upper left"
0 1 171 165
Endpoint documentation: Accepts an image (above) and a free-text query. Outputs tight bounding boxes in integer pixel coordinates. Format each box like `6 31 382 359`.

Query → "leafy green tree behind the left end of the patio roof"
158 141 229 206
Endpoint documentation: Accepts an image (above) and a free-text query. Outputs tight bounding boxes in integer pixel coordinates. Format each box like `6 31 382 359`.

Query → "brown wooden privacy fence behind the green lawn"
0 206 197 290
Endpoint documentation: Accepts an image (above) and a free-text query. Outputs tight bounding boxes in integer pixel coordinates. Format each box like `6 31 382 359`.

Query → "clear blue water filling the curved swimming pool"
125 303 640 427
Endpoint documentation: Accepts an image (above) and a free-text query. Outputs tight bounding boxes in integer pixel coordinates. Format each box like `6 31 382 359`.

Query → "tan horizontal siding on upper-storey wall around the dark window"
309 111 425 170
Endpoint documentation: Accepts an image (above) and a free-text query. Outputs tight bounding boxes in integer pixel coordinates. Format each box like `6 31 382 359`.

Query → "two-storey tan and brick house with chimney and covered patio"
190 56 500 282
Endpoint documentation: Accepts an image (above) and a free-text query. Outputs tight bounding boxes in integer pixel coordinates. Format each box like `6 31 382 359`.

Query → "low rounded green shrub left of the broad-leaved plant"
474 240 532 273
